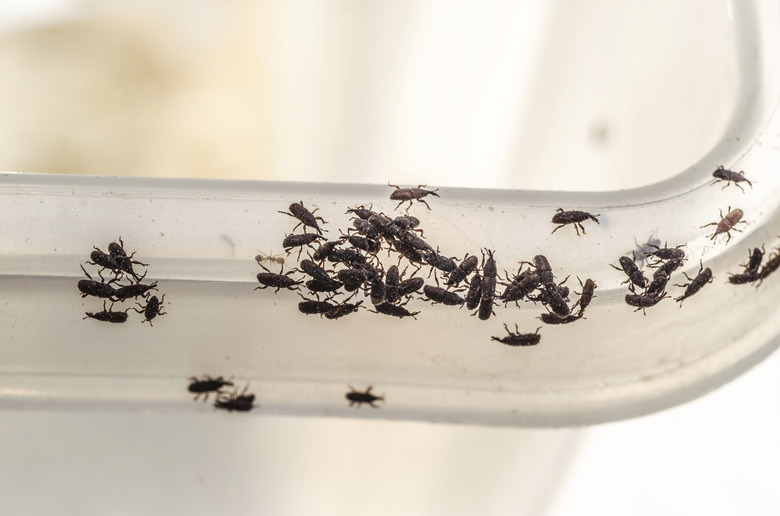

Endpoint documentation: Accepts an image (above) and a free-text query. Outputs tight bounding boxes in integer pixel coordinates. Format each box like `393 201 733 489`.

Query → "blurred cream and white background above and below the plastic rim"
0 0 780 516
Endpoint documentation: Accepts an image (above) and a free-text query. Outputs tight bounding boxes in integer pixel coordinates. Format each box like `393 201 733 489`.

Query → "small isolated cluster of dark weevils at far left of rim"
78 238 165 326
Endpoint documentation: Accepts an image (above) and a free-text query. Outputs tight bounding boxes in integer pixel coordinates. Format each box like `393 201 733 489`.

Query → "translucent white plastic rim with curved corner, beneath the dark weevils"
0 4 780 426
